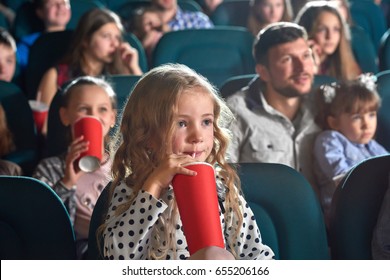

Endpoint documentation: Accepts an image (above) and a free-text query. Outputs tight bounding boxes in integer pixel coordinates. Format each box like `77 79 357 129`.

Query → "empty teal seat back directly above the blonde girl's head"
152 26 255 87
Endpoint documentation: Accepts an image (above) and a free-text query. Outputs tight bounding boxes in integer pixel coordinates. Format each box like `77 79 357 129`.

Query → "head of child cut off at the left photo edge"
0 27 16 82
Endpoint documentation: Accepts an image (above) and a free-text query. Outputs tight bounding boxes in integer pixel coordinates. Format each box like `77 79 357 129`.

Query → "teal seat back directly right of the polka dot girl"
237 163 329 260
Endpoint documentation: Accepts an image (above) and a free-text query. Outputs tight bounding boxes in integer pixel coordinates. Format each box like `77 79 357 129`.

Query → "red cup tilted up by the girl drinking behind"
73 116 103 172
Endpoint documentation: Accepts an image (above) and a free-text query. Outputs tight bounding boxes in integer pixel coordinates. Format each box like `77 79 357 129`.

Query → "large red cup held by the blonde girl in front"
172 162 225 255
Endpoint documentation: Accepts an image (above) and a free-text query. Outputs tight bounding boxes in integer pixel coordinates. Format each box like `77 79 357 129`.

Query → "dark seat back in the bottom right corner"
330 155 390 260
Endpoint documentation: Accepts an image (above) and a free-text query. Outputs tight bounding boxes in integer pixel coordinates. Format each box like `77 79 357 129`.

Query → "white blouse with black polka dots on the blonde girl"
103 180 274 260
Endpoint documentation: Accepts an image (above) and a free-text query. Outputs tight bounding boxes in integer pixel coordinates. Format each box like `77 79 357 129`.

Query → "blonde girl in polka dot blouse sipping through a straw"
100 64 274 260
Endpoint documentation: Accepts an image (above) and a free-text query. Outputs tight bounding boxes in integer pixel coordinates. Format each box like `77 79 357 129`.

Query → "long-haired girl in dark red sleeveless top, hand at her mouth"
37 8 142 115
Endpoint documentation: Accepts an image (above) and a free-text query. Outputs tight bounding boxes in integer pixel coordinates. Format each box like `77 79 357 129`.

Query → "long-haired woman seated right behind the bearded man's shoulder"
295 1 361 80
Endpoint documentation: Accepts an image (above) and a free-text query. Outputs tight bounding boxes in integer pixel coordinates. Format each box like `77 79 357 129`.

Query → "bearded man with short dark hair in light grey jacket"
227 22 319 186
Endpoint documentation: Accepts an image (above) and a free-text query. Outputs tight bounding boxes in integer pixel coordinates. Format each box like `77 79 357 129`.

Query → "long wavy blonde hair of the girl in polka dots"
99 64 243 259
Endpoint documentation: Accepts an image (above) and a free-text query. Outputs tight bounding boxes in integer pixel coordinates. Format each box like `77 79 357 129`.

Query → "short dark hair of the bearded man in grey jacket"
253 22 307 65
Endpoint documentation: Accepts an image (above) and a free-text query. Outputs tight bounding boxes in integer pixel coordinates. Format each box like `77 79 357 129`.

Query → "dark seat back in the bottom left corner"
0 176 76 260
